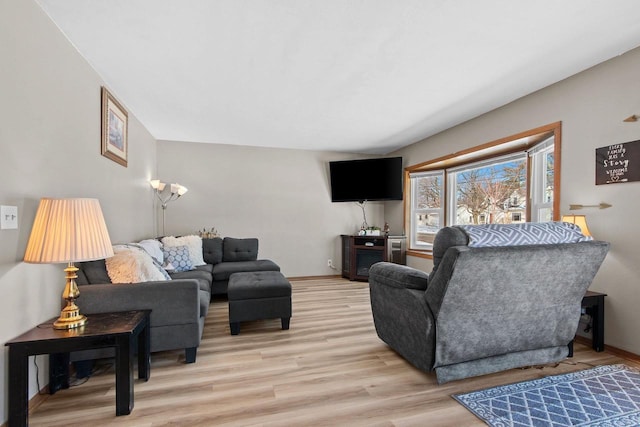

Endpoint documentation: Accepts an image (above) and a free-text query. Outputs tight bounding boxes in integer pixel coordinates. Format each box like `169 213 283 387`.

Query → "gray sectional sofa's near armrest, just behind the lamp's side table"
76 279 200 327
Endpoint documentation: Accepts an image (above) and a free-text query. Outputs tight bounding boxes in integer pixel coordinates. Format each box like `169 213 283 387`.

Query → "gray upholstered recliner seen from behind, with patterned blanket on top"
369 223 609 383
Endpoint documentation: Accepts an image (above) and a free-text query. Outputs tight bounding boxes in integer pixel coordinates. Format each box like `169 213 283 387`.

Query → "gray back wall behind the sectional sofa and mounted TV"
158 141 384 277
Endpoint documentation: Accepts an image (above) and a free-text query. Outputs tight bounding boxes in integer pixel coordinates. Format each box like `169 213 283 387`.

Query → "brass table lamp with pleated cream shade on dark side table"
24 198 113 329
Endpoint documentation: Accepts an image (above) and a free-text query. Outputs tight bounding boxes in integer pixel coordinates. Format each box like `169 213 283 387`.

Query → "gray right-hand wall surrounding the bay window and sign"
385 48 640 354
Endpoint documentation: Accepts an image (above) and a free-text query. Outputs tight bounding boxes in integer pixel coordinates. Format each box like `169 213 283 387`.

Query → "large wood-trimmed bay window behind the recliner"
405 122 561 253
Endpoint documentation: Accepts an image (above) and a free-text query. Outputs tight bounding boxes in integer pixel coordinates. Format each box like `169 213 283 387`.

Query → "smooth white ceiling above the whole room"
36 0 640 154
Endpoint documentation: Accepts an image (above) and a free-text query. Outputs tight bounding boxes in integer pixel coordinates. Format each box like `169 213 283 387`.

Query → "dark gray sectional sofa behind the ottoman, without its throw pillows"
71 237 280 363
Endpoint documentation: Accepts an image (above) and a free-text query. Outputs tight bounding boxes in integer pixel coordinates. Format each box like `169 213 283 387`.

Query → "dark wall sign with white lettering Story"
596 140 640 185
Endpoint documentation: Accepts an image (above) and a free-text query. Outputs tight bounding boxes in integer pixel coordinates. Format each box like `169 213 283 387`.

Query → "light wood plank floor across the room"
30 278 638 426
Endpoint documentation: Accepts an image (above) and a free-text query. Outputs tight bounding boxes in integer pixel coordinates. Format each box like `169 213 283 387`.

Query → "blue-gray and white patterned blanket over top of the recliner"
457 222 593 247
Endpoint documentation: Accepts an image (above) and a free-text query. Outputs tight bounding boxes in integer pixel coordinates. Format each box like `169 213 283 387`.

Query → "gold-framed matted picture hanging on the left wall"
101 86 129 167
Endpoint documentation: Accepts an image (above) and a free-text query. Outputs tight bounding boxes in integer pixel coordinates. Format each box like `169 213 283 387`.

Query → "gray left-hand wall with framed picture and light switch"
0 0 156 420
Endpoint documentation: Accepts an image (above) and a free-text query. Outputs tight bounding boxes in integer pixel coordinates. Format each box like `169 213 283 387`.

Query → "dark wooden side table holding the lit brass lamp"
5 310 151 427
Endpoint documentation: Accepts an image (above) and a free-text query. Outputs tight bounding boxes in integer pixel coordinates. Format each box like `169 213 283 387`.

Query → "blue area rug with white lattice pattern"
453 365 640 427
